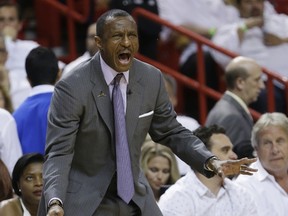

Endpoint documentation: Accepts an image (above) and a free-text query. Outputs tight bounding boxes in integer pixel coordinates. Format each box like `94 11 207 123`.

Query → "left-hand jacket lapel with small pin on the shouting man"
91 53 114 137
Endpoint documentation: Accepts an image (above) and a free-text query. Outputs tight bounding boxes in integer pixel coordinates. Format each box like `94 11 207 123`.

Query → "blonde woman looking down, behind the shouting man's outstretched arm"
141 141 180 201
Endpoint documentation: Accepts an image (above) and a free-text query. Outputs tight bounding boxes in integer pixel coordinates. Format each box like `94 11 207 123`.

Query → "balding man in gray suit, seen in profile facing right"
205 56 264 158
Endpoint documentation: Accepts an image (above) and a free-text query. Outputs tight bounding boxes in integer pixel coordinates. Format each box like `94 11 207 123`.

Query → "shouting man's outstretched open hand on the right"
212 158 257 178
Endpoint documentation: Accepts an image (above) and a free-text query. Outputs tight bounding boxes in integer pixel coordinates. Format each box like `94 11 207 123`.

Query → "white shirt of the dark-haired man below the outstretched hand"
158 170 258 216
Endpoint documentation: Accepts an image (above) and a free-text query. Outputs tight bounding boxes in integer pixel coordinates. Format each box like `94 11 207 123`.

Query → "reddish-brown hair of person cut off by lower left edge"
0 159 13 202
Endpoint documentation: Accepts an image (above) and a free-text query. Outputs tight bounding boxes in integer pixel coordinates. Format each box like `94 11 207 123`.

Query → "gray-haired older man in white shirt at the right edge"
236 113 288 216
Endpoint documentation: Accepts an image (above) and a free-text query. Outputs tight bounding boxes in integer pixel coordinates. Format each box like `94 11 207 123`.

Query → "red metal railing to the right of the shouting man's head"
133 8 288 124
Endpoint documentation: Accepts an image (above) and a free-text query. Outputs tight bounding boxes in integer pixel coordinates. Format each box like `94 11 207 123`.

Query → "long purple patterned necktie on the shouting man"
112 73 134 204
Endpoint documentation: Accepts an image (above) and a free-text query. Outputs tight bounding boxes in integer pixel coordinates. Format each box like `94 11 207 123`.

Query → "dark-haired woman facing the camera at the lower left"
0 153 44 216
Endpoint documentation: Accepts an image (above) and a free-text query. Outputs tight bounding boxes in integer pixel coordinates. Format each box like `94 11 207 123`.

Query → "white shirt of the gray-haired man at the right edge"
235 160 288 216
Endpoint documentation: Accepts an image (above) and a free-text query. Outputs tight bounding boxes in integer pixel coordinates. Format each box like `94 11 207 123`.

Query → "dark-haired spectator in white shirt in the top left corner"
0 1 39 109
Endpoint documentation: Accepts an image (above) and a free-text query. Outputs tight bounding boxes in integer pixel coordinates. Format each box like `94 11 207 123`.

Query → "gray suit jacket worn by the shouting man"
38 53 212 216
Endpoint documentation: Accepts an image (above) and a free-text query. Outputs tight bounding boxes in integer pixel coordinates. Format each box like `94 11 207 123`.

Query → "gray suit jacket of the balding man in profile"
205 94 253 158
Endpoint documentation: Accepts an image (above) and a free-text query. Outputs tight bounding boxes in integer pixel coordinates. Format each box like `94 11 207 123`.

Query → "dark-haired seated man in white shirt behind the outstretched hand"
159 125 257 216
